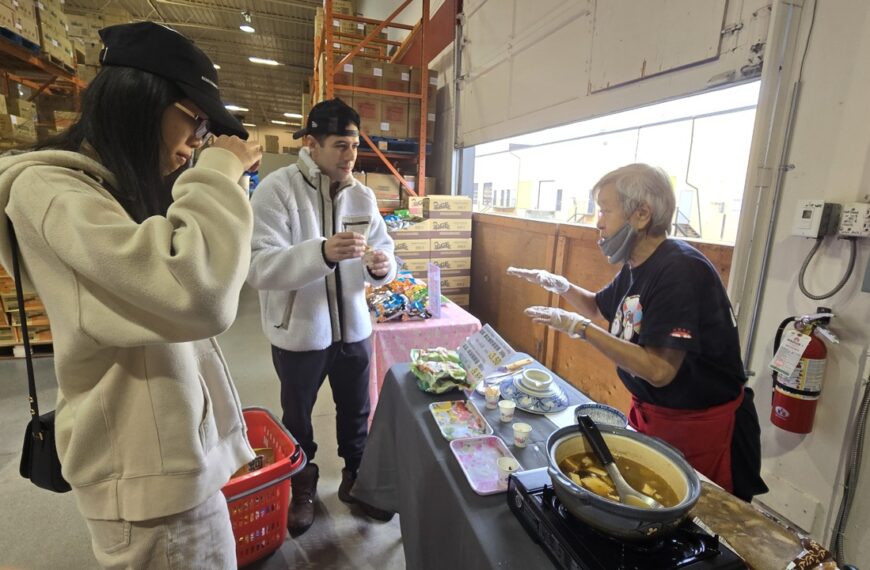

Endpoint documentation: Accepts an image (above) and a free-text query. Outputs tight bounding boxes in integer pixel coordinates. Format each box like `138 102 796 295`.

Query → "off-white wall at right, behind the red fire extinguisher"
735 0 870 564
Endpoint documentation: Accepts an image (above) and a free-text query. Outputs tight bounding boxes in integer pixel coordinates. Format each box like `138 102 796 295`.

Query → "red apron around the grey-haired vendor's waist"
628 390 743 493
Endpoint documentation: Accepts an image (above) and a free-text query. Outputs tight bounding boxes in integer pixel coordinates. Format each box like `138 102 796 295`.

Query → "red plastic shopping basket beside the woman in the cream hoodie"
221 408 306 567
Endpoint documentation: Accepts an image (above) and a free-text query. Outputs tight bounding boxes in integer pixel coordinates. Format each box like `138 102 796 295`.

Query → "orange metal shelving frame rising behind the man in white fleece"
311 0 429 196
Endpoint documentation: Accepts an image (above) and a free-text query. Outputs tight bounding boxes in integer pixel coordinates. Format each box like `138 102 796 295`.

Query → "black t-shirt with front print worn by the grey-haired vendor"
595 239 746 410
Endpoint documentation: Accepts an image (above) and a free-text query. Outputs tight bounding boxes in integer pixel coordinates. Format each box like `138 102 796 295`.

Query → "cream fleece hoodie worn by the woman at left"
0 148 254 521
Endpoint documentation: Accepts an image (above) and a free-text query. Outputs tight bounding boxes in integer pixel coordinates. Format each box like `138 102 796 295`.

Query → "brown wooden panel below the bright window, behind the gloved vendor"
471 214 733 411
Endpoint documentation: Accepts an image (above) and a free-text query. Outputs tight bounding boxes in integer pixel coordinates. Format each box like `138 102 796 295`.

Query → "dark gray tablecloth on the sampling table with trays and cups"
353 363 589 570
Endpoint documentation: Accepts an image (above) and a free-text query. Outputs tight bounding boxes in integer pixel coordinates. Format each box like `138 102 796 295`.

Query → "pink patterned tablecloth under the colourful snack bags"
369 303 480 422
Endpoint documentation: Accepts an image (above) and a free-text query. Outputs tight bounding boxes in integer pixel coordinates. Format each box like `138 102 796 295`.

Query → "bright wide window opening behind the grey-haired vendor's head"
474 82 759 244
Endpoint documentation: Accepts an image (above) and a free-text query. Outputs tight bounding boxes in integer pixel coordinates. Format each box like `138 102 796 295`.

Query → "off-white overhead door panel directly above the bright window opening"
461 0 768 146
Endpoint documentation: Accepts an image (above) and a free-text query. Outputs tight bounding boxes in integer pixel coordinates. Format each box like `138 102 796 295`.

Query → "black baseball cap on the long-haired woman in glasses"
100 22 248 140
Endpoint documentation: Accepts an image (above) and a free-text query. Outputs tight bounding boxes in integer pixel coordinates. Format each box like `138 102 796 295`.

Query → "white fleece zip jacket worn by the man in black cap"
248 148 396 351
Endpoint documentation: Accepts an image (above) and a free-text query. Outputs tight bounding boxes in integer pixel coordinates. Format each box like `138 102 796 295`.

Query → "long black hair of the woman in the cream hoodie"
34 66 184 222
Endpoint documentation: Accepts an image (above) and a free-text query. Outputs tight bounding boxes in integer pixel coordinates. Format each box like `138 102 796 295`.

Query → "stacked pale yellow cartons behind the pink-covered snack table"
390 193 471 307
